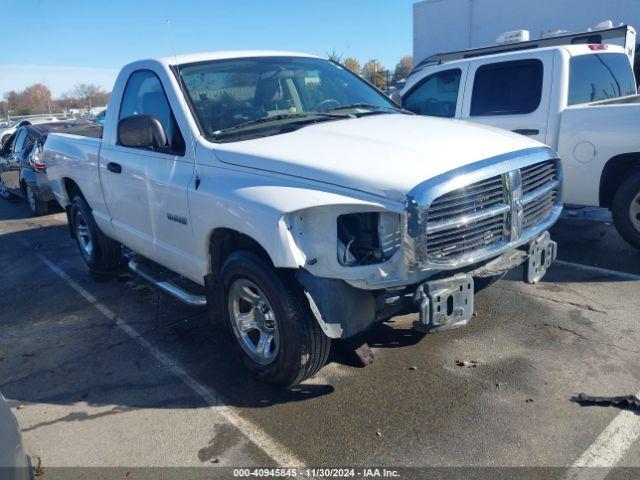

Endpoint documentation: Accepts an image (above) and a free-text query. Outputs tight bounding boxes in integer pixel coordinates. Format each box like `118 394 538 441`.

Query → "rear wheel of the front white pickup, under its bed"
69 196 122 273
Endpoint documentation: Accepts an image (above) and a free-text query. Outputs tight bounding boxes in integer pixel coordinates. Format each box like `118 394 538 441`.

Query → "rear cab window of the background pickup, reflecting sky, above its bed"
569 53 637 105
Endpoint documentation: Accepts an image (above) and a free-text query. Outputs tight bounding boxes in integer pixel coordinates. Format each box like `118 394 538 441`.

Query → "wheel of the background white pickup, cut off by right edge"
611 173 640 249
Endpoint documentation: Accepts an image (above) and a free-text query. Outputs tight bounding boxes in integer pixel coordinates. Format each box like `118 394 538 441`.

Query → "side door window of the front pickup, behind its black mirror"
118 70 185 155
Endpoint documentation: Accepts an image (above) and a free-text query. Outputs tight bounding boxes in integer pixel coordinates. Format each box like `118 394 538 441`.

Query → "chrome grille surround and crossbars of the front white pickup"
403 147 563 271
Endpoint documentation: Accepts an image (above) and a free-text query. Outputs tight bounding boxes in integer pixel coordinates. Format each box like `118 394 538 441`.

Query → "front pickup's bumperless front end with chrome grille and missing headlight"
289 148 562 339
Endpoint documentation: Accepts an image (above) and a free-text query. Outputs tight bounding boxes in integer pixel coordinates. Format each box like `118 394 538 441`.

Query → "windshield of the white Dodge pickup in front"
179 57 400 141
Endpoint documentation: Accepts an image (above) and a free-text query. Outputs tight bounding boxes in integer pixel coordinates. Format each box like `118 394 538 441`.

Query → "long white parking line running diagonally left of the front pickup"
31 253 305 468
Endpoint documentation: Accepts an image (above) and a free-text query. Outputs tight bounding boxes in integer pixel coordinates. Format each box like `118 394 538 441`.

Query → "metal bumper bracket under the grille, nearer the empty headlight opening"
414 274 474 333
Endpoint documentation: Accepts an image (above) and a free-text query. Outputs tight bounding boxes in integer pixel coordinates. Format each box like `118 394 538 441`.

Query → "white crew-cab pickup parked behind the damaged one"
401 41 640 248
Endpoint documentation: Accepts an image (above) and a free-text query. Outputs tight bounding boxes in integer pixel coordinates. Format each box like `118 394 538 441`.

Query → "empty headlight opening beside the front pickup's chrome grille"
338 212 401 267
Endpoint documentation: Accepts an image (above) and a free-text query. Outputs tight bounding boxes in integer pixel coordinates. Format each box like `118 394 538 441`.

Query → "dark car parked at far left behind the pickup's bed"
0 122 84 215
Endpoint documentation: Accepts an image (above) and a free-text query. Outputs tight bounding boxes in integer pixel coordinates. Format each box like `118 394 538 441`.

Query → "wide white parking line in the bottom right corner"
565 392 640 480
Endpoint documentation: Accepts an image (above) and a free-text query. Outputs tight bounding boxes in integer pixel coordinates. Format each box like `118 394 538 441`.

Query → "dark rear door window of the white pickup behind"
471 59 543 116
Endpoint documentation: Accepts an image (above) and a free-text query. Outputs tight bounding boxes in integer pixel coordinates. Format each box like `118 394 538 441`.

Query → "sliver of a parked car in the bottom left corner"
0 393 33 480
